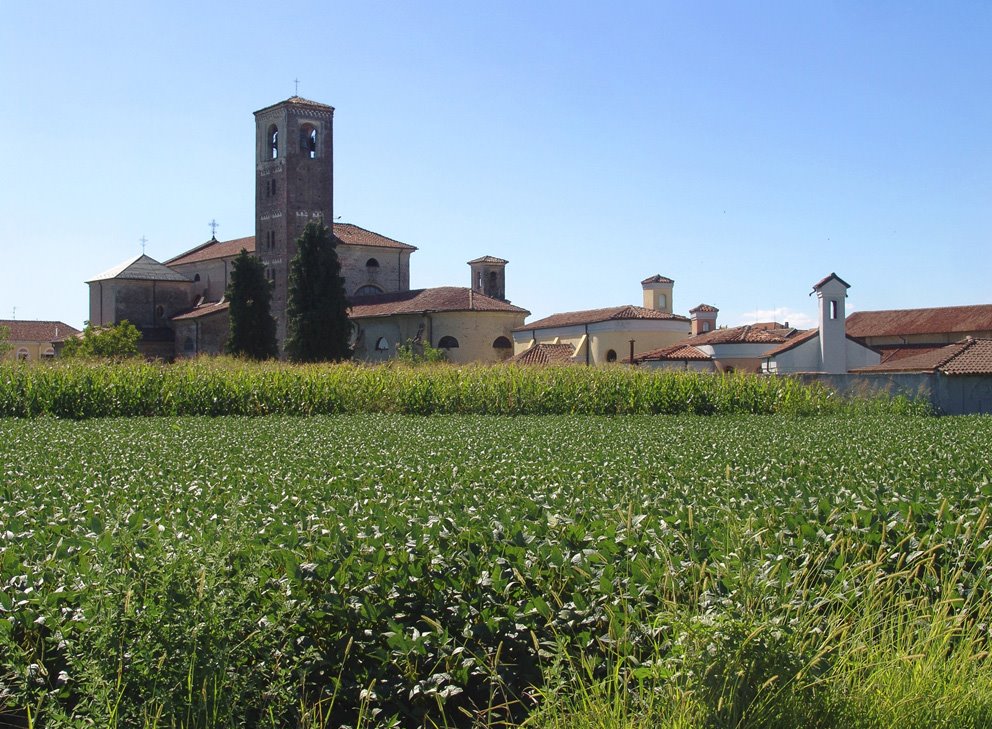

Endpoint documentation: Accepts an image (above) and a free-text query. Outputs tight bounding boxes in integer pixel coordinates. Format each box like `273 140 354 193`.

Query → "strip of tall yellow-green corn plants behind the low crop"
0 358 923 419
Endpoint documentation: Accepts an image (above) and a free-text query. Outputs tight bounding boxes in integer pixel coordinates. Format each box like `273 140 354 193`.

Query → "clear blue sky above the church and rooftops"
0 0 992 326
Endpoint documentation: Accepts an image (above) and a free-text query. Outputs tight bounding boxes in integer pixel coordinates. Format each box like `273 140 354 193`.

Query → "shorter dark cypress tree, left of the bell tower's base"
224 248 279 359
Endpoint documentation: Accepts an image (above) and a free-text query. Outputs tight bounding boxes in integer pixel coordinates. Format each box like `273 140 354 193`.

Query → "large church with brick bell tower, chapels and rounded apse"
86 96 530 363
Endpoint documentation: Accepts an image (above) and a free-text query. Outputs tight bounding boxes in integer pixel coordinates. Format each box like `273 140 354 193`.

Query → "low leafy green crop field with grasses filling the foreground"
0 413 992 727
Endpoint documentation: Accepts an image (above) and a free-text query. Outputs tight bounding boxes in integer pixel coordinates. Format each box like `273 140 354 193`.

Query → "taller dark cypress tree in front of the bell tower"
286 222 351 362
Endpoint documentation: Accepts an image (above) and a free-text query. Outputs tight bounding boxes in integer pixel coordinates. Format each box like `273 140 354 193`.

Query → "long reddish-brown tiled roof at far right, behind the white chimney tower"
847 304 992 337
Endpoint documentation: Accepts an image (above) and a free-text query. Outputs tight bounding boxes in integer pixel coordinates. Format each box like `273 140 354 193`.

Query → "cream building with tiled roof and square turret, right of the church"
513 275 691 365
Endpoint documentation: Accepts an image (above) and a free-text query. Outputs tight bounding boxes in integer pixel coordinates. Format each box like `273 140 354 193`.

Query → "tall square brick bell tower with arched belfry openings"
255 96 334 350
